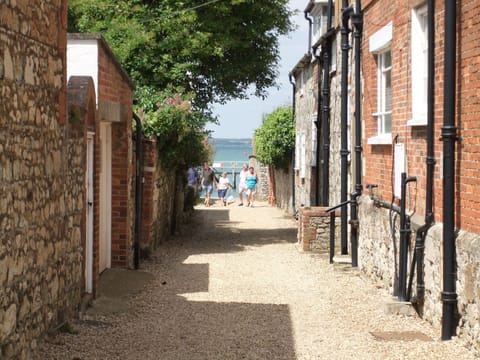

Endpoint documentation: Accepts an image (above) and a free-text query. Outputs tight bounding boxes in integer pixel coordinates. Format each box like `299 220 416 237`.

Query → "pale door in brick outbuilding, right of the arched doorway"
99 122 112 272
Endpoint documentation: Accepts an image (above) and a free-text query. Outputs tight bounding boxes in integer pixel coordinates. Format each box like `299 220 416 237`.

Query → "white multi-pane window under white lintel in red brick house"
368 49 392 144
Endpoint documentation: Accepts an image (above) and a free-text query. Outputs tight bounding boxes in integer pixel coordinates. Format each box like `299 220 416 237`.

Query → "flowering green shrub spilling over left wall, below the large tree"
136 88 213 168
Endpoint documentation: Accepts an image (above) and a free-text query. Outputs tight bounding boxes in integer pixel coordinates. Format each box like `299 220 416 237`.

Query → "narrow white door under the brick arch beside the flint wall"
85 133 94 294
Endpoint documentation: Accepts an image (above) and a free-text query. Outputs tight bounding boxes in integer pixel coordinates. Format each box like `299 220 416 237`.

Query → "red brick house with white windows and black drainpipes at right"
360 0 480 347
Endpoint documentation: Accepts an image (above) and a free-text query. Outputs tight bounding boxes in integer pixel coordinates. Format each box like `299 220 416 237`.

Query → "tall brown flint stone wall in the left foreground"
0 0 84 359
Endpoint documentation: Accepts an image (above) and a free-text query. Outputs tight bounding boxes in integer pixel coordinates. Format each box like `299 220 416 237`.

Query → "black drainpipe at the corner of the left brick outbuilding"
133 113 143 270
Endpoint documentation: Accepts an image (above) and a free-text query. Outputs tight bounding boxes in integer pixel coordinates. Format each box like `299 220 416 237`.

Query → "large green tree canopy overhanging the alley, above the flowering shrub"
68 0 293 109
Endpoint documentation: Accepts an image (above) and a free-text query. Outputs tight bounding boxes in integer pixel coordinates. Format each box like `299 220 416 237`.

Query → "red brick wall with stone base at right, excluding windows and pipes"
359 0 480 349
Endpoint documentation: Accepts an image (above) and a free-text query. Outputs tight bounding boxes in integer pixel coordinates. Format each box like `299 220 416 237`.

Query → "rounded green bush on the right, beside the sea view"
255 106 295 169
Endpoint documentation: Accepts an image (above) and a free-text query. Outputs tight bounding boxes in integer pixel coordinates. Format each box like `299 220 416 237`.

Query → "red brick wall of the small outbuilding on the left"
98 39 135 267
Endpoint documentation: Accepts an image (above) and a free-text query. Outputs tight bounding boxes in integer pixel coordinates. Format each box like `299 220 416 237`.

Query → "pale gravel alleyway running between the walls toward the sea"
37 203 474 360
